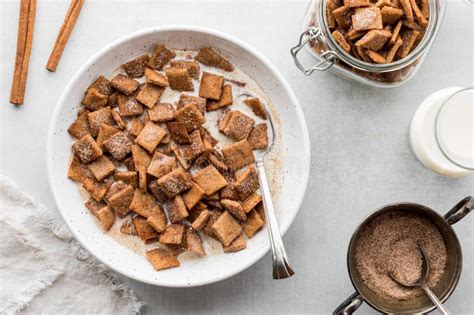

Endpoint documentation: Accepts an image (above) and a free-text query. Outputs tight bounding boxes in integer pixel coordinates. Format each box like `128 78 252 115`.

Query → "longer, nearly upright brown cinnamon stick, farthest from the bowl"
10 0 36 105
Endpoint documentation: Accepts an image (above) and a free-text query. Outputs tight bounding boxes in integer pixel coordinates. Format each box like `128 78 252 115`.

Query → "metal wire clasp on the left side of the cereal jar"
290 27 337 75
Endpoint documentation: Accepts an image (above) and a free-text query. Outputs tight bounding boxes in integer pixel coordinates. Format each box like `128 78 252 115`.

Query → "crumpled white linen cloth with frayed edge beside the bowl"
0 175 144 315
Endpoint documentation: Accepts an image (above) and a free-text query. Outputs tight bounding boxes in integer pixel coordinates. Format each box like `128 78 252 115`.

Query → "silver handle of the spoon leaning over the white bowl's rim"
256 159 295 279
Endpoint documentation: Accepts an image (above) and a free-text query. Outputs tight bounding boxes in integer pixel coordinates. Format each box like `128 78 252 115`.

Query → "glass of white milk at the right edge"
410 87 474 177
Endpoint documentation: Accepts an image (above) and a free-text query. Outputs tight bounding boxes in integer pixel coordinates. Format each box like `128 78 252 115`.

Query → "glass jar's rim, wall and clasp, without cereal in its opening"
291 0 447 88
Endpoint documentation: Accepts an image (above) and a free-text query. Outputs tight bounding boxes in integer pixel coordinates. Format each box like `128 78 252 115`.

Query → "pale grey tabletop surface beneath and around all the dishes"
0 0 474 314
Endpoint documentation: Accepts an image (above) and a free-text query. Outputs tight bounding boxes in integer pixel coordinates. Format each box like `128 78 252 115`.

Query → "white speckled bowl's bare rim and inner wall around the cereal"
47 26 310 287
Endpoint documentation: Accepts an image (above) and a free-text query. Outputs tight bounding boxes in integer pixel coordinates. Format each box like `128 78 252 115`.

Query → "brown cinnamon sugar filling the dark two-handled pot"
355 211 447 300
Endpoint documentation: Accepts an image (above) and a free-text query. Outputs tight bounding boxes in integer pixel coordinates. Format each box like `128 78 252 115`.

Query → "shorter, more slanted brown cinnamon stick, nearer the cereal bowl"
46 0 84 72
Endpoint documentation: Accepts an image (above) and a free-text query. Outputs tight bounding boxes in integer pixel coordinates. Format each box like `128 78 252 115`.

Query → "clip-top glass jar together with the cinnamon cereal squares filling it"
292 0 446 87
